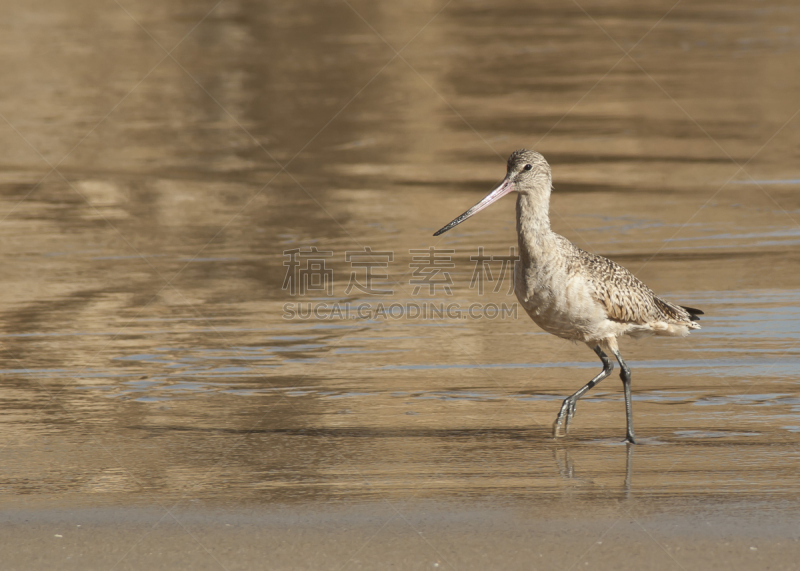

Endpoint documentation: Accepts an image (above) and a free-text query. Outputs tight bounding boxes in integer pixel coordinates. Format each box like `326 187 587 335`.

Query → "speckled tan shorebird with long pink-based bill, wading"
434 149 703 444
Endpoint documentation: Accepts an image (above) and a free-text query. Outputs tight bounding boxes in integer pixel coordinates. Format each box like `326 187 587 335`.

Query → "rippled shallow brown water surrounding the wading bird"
0 0 800 568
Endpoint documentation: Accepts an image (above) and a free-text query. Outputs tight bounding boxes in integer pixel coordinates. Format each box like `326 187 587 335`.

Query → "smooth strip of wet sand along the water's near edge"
0 501 800 570
